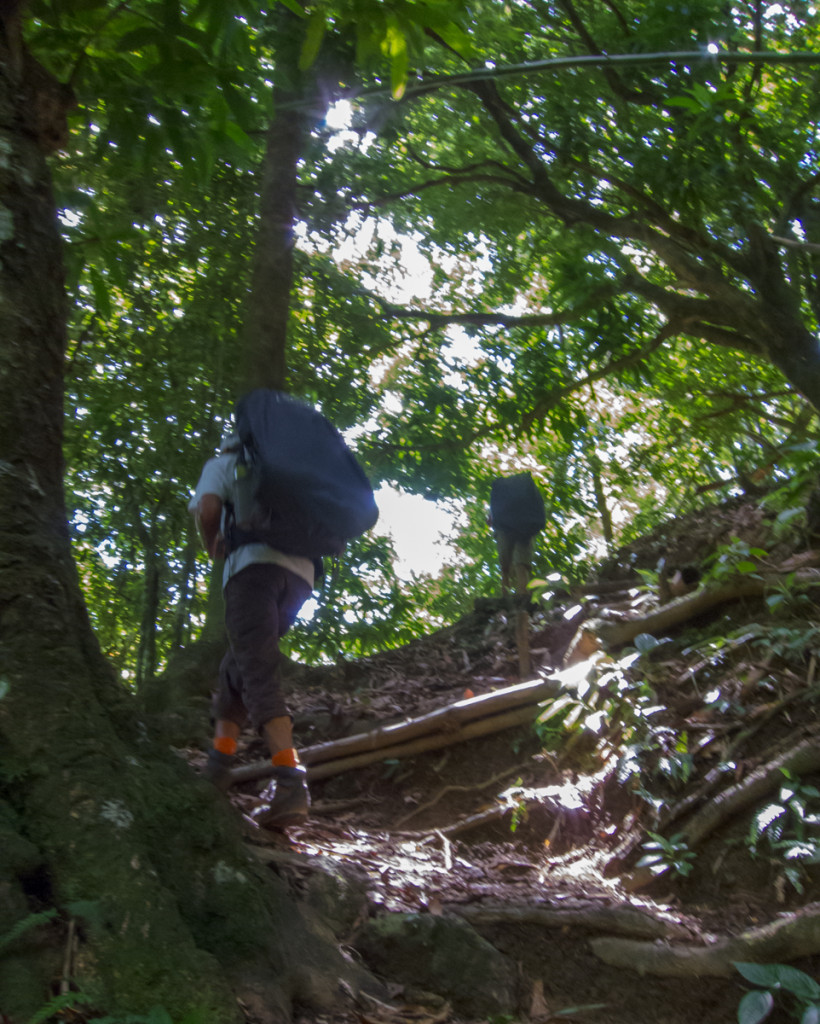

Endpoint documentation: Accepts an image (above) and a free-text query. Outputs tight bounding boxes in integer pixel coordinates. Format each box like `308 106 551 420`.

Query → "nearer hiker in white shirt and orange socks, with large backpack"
188 388 379 828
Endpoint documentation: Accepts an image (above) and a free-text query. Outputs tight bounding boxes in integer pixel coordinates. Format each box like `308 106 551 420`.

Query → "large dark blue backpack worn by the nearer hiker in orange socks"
228 388 379 559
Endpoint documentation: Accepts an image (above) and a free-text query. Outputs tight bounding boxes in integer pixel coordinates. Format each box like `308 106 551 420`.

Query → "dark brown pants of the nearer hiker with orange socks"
213 562 310 731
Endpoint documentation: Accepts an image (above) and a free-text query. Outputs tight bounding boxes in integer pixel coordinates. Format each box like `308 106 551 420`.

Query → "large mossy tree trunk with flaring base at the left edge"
0 35 364 1024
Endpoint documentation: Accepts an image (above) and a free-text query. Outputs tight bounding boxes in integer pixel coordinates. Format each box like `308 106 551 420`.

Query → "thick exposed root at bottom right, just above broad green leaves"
590 903 820 978
